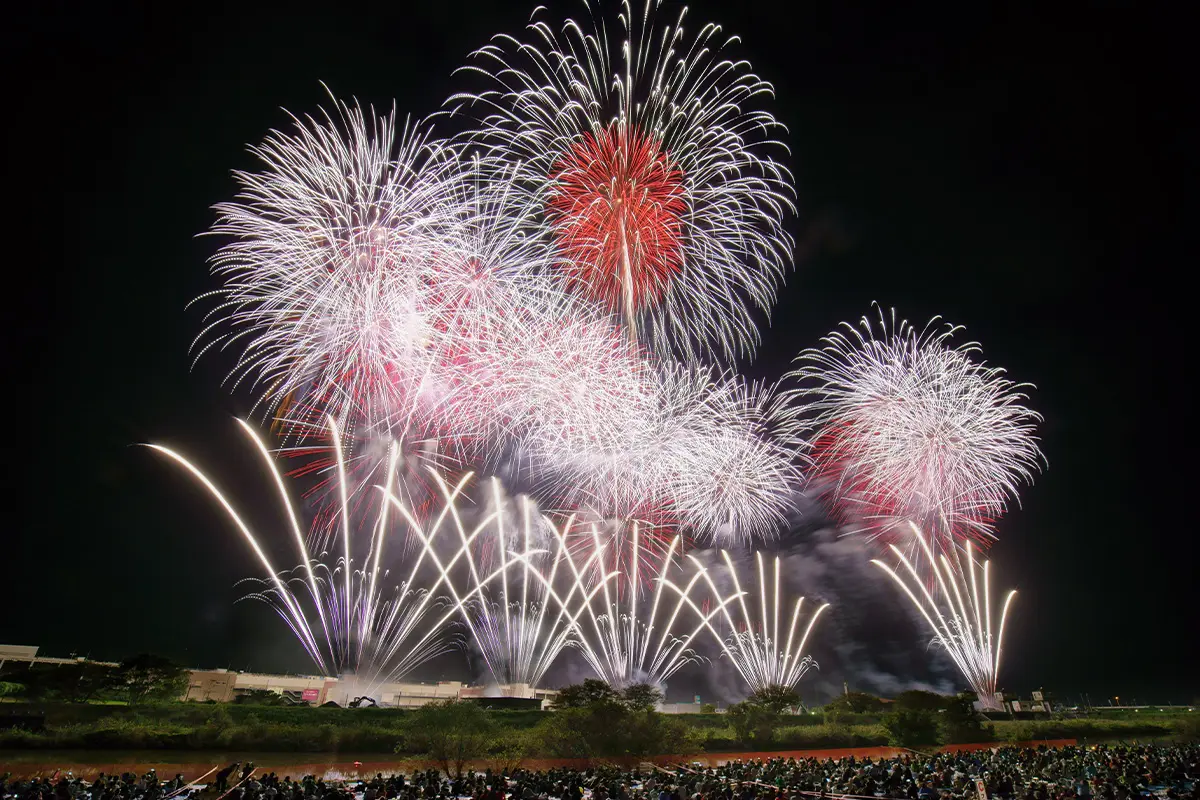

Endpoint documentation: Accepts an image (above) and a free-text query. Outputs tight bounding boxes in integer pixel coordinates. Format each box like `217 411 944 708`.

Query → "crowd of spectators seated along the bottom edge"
0 745 1200 800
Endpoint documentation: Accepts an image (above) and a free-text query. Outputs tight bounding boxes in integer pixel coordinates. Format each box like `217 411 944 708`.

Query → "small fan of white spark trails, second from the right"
689 551 829 692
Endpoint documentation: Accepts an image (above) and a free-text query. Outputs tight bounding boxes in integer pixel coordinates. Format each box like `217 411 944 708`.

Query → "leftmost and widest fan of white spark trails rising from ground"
149 419 523 693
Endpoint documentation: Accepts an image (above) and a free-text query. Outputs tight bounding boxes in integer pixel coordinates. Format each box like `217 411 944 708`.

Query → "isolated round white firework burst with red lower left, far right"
787 308 1043 551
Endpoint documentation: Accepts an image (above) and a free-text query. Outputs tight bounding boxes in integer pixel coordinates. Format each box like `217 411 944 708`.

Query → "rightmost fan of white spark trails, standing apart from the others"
871 523 1016 709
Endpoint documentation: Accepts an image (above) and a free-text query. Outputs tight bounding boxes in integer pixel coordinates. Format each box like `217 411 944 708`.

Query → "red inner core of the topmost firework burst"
547 124 688 318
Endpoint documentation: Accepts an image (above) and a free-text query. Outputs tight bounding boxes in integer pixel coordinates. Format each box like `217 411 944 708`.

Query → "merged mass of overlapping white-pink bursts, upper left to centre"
197 90 797 546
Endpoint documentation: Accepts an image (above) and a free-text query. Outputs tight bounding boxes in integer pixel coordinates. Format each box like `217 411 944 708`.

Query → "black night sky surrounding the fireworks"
7 0 1200 702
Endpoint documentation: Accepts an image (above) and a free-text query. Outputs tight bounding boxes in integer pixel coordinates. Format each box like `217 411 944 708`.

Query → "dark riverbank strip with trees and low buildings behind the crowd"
0 648 1200 770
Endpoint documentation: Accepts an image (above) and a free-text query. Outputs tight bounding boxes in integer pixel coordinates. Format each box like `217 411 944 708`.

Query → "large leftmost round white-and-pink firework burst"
196 103 461 438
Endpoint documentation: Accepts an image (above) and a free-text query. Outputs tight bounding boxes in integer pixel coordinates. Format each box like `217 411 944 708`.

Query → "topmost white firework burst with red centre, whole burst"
446 0 794 356
